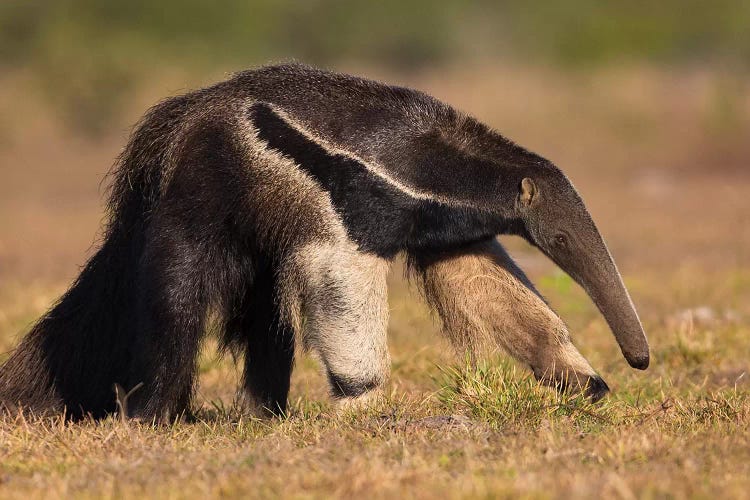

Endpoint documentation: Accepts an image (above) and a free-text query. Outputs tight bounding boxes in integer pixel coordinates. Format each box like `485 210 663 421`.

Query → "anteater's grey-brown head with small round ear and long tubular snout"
516 166 649 370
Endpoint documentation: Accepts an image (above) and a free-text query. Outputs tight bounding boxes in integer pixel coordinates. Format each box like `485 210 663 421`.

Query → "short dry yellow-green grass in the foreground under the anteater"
0 270 750 498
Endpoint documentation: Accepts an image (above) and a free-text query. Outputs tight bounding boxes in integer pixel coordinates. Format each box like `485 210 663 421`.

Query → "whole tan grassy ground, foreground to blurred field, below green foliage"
0 67 750 499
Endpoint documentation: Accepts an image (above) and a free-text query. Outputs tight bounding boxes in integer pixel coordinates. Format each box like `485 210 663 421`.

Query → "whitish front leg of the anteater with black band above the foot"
287 243 390 406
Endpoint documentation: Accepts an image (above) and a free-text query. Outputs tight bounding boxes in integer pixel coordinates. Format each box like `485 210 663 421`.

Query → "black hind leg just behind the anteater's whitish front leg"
224 260 294 415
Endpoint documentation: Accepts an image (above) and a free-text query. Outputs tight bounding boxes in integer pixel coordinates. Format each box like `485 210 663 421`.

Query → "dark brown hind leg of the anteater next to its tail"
125 213 211 421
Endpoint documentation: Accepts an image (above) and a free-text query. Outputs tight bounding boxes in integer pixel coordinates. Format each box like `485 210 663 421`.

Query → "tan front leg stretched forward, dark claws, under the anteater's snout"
411 239 608 400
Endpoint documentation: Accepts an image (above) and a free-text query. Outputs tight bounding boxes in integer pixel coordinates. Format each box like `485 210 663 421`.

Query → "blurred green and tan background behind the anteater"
0 0 750 390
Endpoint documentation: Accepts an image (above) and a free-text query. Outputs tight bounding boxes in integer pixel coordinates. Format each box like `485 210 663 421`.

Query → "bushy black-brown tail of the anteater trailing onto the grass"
0 217 142 418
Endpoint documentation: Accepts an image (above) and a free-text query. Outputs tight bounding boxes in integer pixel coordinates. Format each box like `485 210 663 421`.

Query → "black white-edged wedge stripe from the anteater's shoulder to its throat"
249 103 504 258
